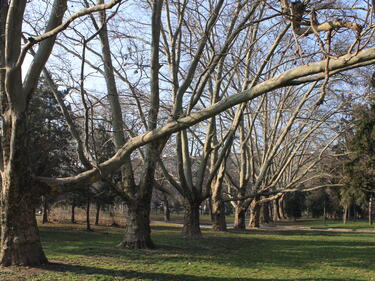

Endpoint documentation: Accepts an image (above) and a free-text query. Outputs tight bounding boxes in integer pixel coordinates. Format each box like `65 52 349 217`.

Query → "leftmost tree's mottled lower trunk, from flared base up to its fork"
0 109 48 266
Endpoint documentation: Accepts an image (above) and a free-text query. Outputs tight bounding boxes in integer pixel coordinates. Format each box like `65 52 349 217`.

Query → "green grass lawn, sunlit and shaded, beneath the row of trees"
0 221 375 281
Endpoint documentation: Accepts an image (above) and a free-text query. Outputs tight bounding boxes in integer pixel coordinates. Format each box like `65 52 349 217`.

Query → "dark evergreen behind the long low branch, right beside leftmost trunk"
27 81 74 223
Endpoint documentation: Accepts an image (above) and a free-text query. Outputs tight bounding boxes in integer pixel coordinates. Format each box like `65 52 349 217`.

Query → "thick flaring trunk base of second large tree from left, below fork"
118 200 155 249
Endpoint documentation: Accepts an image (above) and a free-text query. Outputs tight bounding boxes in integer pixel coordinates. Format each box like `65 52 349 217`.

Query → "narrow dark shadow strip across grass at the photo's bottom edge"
40 263 365 281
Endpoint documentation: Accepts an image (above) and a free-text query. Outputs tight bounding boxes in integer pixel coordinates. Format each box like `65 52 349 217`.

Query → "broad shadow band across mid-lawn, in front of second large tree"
50 232 373 274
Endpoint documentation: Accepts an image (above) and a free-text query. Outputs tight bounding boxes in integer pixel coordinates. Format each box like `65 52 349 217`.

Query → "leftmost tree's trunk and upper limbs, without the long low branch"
0 0 122 265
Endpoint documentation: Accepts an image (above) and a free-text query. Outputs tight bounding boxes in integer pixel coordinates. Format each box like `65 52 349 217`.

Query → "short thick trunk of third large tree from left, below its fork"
182 202 202 239
